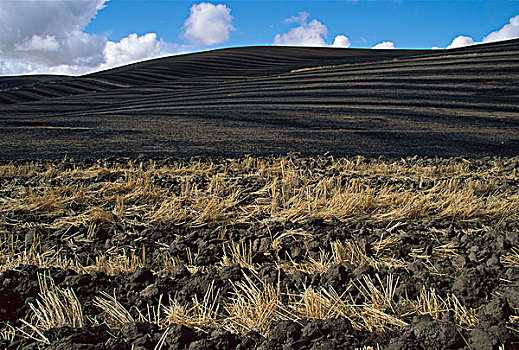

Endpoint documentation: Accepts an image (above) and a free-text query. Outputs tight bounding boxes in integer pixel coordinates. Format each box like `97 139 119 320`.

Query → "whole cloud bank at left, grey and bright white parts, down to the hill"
0 0 171 75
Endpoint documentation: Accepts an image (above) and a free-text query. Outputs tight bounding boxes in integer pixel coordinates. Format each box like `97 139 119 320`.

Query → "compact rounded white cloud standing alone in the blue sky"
182 2 234 46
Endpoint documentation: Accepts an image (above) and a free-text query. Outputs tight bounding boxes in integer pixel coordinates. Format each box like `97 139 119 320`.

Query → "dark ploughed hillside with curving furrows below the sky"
0 40 519 158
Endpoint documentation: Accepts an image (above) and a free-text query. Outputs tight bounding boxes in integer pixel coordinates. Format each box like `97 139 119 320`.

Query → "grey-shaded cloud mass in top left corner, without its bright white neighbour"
0 0 107 67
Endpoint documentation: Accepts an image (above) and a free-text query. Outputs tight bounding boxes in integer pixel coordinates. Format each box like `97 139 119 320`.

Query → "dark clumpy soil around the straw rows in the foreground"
0 158 519 349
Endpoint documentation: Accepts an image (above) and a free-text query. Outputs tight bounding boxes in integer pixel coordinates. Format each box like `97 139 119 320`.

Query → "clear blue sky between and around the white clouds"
87 0 519 48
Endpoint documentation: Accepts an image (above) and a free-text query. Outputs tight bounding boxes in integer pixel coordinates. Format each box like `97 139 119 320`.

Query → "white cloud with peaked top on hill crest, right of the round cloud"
274 12 328 46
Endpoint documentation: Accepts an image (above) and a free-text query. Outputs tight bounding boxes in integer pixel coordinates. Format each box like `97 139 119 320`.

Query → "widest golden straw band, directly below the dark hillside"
0 157 519 234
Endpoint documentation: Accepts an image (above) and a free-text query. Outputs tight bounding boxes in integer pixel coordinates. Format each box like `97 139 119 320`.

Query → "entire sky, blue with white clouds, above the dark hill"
0 0 519 75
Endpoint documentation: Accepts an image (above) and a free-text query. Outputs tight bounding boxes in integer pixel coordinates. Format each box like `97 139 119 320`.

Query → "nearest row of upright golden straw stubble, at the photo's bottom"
10 275 482 344
